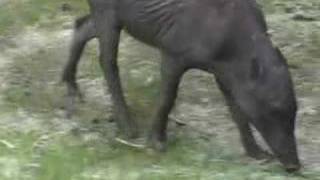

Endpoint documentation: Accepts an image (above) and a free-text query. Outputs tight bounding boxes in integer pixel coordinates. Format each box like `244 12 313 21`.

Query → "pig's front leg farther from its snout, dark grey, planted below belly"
149 55 186 151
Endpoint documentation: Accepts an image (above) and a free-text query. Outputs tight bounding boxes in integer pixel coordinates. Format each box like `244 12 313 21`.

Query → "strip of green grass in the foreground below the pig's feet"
0 133 316 180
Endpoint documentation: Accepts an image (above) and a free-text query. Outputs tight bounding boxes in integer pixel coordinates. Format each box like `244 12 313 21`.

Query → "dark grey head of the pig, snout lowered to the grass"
252 36 301 172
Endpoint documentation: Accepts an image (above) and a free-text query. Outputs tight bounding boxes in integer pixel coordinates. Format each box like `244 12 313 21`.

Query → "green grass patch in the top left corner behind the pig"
0 0 88 35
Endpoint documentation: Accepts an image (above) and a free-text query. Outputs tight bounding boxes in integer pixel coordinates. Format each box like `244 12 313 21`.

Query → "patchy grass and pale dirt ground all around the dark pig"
0 0 320 180
